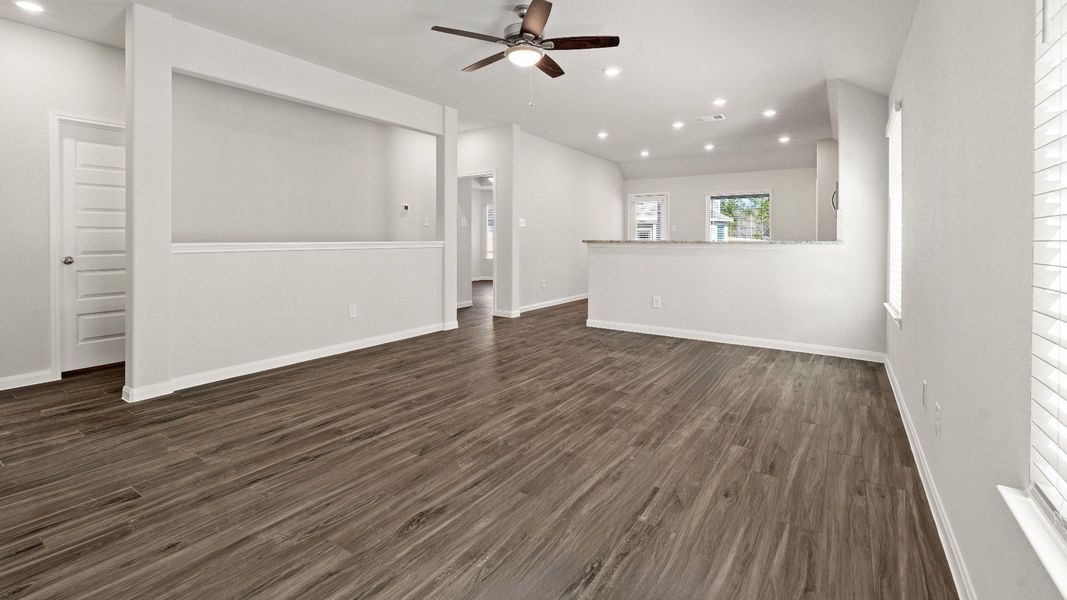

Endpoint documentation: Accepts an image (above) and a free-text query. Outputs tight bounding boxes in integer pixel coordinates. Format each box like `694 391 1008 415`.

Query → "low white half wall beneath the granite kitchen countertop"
589 244 882 360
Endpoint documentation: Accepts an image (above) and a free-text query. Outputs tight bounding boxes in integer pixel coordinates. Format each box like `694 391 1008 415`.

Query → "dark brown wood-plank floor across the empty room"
0 285 956 600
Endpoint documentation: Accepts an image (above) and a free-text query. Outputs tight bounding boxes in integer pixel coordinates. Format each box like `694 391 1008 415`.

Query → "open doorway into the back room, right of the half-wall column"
456 173 496 321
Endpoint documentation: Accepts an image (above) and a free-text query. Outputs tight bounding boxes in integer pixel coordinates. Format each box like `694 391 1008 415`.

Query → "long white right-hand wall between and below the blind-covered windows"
879 0 1058 600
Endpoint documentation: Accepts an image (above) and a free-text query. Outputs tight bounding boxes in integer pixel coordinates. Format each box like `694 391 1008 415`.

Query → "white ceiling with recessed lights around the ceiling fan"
0 0 919 177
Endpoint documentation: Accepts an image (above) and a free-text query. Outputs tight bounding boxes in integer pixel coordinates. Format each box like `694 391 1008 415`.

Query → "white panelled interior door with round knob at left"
60 124 126 370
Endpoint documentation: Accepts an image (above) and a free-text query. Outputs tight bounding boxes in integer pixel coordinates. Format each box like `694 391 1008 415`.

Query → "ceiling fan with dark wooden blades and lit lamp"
430 0 619 78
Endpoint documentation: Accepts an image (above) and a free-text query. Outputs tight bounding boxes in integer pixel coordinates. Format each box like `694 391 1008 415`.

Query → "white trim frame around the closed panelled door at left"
48 110 129 373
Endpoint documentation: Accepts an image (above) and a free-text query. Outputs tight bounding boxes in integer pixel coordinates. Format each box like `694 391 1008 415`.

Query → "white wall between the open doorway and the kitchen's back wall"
519 133 625 310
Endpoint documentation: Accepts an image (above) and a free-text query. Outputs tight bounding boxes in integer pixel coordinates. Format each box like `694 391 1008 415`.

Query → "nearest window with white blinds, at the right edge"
1030 0 1067 525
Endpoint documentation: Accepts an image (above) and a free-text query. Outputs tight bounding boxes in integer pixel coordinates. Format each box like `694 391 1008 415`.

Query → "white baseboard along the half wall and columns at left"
123 321 448 402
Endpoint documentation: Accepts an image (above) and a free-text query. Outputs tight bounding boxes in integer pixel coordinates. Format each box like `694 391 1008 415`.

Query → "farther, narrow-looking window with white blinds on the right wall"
883 100 904 327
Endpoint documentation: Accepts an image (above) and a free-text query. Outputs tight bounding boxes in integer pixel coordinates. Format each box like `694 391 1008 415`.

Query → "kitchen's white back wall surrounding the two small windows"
622 168 815 241
